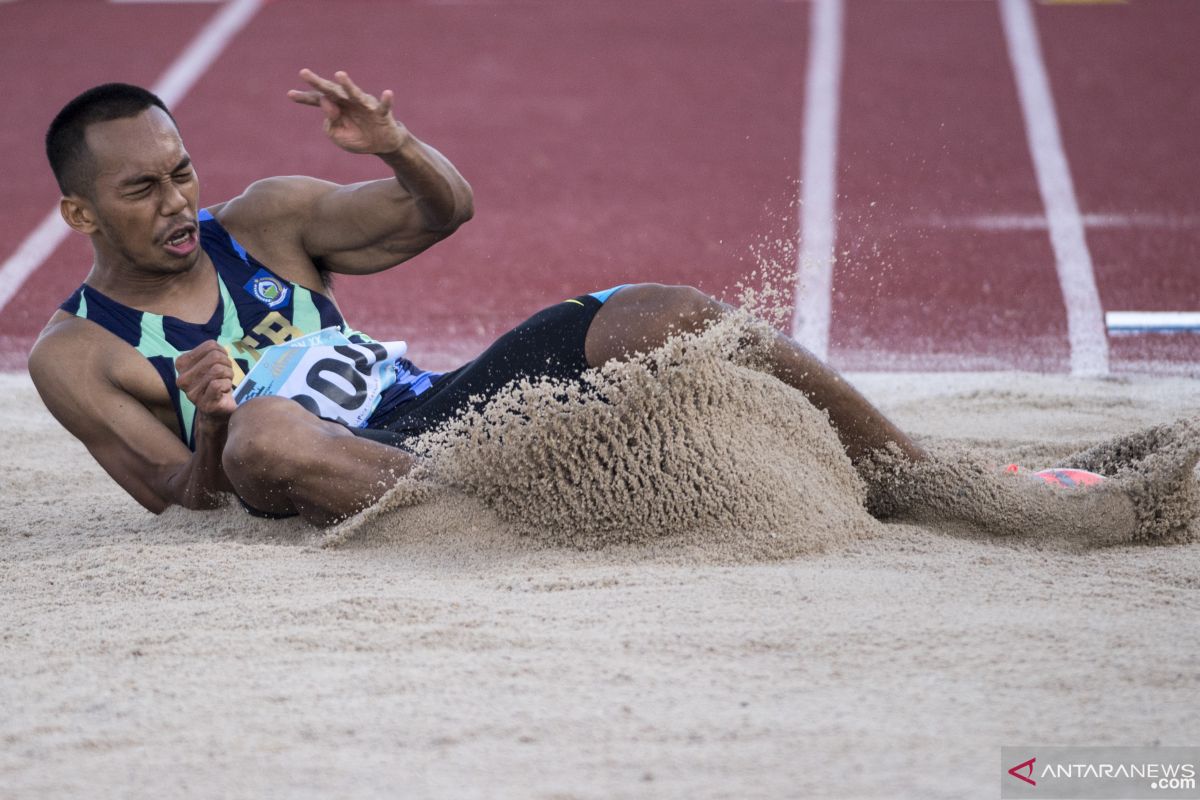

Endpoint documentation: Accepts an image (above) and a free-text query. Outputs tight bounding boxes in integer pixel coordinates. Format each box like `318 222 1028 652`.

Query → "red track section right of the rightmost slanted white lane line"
1038 0 1200 374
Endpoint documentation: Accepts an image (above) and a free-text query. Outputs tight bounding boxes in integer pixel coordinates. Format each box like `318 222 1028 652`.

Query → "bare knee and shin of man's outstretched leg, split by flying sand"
586 283 925 462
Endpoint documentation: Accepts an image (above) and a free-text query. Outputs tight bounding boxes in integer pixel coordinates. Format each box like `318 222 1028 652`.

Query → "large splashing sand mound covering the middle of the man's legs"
330 314 876 558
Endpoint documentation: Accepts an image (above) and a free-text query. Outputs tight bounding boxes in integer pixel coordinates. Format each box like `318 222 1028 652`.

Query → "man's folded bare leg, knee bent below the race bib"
222 397 413 525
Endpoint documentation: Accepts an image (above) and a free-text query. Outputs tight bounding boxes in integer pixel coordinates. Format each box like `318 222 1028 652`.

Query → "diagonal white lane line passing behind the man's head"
0 0 263 319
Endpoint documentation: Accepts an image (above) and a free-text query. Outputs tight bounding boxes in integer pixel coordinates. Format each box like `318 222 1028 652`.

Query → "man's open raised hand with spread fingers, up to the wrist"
288 68 409 154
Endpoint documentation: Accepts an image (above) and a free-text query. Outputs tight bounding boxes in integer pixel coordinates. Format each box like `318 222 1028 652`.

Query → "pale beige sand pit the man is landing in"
0 365 1200 798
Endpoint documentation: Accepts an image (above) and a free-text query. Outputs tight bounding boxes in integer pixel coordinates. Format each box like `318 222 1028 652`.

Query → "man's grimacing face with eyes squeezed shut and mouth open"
68 108 200 273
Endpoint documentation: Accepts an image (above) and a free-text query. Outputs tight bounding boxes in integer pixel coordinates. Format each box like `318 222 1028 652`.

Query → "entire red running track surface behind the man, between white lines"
0 0 1200 374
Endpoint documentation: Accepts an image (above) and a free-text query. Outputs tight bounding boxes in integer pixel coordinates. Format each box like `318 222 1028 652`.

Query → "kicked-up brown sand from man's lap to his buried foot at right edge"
325 240 1200 560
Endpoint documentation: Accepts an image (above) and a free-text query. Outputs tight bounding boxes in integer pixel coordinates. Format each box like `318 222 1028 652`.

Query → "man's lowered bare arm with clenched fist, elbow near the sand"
29 320 233 513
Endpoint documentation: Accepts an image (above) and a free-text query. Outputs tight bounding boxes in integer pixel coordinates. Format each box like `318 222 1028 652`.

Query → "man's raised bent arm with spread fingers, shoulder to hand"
288 70 474 273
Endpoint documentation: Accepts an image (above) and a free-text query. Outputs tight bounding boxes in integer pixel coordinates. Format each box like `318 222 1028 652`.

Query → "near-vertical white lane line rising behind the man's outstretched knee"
792 0 842 359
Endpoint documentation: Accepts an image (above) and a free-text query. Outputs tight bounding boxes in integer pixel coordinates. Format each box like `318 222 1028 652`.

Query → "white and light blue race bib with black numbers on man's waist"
233 327 408 428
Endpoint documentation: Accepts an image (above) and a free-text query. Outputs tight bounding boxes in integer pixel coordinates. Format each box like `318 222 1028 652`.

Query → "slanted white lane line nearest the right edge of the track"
1000 0 1109 375
